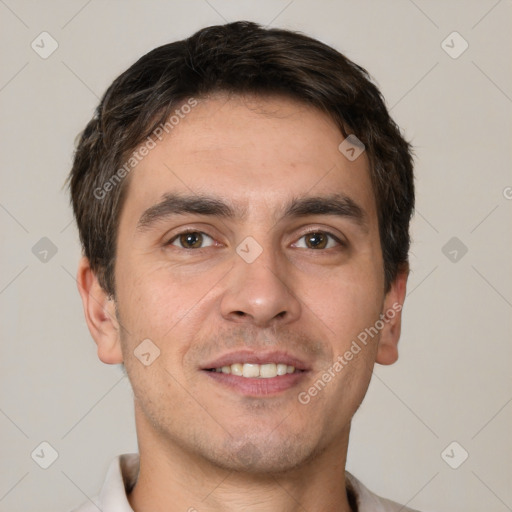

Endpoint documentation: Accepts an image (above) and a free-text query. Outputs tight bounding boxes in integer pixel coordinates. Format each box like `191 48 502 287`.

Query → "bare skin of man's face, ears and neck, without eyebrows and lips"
78 95 407 512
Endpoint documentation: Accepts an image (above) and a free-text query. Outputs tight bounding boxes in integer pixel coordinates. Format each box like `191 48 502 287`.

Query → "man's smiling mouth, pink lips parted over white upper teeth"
201 352 310 397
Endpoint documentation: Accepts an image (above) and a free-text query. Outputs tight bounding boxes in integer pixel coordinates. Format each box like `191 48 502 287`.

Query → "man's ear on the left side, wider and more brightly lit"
76 257 123 364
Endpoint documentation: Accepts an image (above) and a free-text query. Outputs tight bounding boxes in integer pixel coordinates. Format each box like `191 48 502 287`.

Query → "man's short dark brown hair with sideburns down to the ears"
68 21 414 296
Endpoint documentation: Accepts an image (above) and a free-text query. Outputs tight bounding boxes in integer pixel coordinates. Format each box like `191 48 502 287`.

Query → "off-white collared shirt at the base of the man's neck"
72 453 417 512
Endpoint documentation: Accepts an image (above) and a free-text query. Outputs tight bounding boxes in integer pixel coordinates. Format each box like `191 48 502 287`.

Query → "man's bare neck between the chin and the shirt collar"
128 406 351 512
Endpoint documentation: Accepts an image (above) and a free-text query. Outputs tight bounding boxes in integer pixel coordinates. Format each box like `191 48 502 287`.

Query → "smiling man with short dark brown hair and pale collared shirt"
70 22 414 512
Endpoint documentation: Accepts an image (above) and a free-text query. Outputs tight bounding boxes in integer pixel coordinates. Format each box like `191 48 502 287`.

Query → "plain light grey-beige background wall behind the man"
0 0 512 512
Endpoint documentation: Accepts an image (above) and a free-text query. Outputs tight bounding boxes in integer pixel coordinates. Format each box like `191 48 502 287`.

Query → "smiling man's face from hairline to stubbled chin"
80 96 405 472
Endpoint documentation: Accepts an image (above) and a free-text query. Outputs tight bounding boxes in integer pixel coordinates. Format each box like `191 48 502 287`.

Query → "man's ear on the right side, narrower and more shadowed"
376 268 409 365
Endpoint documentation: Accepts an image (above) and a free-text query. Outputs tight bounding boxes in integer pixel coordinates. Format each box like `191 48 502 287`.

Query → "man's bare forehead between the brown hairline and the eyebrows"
122 95 375 225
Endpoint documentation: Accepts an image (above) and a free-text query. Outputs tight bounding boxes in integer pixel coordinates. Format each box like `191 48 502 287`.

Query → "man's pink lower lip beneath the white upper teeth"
204 371 308 397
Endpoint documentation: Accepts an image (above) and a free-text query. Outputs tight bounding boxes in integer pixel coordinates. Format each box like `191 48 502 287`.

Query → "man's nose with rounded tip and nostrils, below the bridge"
220 248 301 327
